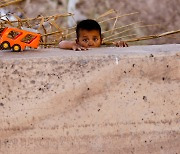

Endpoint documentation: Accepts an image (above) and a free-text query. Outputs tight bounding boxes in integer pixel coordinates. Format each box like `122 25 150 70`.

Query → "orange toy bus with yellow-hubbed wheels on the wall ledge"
0 27 41 52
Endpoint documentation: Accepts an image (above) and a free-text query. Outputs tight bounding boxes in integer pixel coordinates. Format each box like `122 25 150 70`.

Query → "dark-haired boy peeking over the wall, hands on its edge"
59 19 128 50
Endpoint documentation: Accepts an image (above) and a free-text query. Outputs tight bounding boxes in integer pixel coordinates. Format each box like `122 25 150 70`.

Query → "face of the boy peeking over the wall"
77 29 102 48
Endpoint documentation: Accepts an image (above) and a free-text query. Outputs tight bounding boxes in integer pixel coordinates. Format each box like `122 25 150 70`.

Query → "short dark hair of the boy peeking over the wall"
76 19 101 39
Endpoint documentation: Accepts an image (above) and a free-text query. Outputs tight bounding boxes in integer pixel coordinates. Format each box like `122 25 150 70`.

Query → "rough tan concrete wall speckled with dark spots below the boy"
0 44 180 154
